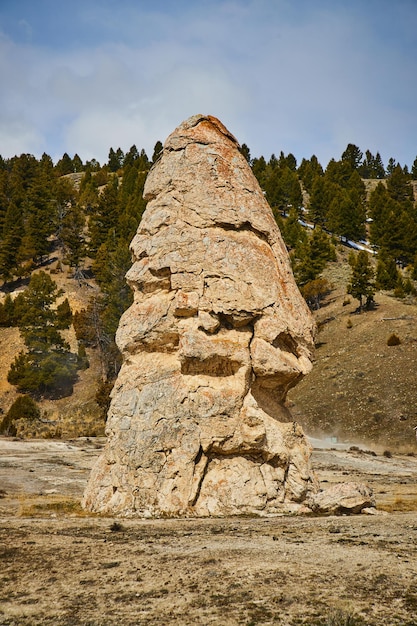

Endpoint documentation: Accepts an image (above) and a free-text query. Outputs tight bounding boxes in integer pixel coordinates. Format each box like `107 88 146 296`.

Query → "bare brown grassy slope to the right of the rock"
288 250 417 452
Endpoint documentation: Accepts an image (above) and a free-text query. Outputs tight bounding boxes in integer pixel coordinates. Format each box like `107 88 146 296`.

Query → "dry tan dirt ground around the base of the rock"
0 438 417 626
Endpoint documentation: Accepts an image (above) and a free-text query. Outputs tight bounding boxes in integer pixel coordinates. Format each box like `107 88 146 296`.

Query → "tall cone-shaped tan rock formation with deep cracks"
84 115 317 516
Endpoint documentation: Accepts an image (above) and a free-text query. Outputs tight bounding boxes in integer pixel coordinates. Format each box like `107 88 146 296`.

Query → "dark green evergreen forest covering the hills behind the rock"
0 141 417 412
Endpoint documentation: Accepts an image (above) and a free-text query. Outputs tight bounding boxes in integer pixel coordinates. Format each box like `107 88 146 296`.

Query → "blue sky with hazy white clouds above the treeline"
0 0 417 168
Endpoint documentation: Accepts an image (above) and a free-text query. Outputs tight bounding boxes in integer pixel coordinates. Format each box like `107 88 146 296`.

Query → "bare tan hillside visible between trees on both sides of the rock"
0 239 417 452
